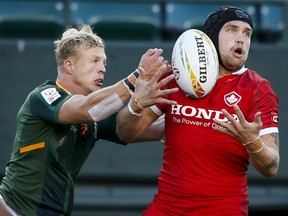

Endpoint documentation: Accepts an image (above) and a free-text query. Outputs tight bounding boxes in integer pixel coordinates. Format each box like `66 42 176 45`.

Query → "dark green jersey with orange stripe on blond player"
0 81 125 216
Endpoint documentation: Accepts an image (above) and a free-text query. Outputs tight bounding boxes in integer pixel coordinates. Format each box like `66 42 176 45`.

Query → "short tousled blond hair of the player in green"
54 25 105 66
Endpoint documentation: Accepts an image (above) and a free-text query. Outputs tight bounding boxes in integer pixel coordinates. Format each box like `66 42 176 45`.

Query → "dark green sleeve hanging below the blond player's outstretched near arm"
97 113 127 145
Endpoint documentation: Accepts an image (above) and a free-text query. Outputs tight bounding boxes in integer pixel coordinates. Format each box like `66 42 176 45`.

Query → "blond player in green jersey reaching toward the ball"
0 25 177 216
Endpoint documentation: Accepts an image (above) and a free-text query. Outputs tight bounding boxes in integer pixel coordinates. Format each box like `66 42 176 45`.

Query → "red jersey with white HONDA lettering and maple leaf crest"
147 68 278 215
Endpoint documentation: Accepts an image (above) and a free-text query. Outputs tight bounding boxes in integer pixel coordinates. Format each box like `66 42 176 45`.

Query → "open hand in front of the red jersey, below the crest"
213 105 262 144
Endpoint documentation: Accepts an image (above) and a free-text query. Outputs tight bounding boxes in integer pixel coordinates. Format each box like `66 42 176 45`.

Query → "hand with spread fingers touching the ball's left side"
133 64 179 108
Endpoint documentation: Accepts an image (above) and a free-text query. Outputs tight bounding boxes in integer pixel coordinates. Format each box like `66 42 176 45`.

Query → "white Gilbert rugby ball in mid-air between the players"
171 29 219 98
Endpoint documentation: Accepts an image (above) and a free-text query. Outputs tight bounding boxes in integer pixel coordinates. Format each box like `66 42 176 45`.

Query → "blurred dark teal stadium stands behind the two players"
0 0 288 216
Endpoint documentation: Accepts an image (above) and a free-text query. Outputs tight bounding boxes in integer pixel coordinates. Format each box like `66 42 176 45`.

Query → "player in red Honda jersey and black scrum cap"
118 7 280 216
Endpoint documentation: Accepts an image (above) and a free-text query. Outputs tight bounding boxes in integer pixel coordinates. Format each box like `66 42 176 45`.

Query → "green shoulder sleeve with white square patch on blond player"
29 85 71 123
